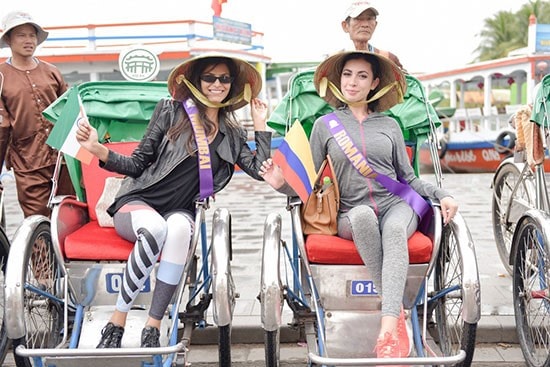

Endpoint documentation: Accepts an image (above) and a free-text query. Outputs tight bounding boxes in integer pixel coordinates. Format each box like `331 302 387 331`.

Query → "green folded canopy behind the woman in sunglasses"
43 81 171 201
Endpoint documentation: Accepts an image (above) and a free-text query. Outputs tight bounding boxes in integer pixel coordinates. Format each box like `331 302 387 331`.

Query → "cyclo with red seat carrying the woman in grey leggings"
260 70 481 366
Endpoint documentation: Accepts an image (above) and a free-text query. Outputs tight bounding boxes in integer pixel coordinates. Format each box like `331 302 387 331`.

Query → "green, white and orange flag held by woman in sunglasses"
46 87 93 164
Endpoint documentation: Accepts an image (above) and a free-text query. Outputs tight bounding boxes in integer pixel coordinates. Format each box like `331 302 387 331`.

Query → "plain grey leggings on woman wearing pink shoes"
338 201 418 317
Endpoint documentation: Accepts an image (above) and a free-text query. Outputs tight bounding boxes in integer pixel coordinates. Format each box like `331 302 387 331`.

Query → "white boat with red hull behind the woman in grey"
418 15 550 173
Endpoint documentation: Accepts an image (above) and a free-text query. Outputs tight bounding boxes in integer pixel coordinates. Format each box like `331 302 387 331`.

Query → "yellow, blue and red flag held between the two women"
273 121 317 203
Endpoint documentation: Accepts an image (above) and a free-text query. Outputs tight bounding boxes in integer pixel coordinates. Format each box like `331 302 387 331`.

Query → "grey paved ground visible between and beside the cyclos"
3 174 524 366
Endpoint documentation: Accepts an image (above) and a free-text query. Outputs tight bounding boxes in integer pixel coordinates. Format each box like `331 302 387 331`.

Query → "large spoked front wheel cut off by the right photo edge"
512 217 550 367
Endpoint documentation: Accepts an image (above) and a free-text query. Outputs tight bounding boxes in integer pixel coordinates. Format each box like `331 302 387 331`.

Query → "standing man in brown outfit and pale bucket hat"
0 11 74 217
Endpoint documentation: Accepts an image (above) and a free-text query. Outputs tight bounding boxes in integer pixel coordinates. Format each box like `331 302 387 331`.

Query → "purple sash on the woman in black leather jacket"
182 98 214 200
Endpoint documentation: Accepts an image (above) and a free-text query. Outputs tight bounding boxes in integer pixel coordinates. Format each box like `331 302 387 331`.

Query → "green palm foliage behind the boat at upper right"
474 0 550 62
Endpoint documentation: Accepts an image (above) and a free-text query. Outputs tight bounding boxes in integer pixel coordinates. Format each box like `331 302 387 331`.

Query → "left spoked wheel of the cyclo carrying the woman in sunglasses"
12 222 64 367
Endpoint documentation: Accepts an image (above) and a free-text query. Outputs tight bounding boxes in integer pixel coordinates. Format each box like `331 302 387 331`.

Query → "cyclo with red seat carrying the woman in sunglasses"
5 82 235 367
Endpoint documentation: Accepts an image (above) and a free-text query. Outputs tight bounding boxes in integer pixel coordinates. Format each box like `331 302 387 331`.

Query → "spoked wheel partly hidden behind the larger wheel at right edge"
491 162 535 275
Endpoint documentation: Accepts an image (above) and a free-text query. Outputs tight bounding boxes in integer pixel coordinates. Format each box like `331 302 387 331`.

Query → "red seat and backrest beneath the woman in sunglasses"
64 141 138 261
